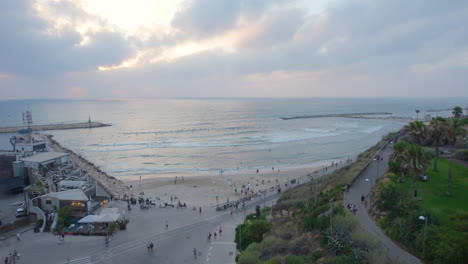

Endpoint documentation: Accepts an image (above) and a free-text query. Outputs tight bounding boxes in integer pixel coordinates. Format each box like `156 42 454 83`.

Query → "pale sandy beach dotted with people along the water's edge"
125 157 355 207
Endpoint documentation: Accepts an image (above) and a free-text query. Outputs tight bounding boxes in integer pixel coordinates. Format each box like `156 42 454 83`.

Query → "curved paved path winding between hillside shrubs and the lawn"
344 144 421 263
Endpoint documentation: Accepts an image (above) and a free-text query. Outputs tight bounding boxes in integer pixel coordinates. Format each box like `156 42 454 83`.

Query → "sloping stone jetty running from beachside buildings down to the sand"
40 135 128 199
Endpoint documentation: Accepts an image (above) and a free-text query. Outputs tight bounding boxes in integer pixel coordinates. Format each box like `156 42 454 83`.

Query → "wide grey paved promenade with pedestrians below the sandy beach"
0 186 286 264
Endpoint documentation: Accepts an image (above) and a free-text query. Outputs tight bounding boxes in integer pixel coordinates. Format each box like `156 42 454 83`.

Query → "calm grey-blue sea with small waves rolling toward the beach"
0 98 468 181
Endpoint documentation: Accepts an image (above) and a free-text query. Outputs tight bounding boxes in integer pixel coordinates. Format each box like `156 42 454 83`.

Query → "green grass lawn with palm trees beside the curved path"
414 158 468 225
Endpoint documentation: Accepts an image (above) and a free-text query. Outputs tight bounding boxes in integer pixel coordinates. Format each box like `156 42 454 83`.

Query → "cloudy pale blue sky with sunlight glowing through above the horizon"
0 0 468 100
